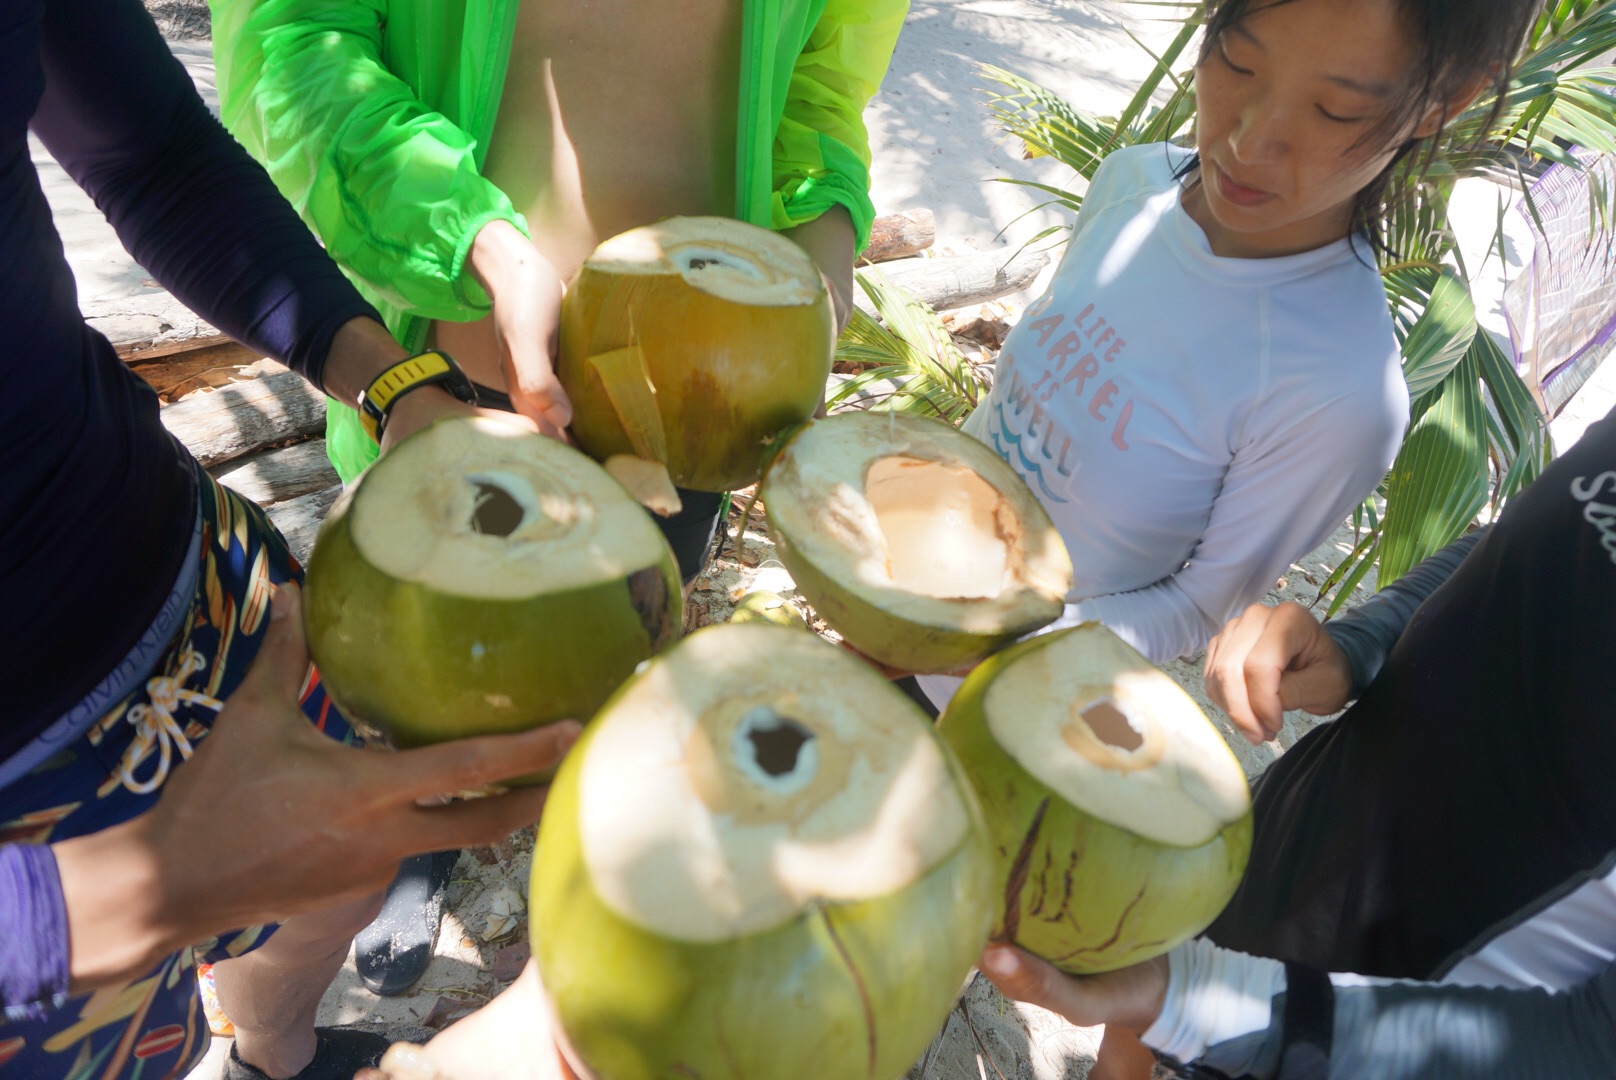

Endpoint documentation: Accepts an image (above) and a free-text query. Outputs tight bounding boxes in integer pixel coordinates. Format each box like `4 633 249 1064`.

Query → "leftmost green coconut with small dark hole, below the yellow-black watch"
304 419 680 759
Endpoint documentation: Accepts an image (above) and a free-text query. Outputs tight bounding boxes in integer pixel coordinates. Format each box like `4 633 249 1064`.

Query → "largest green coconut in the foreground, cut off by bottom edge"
532 622 994 1080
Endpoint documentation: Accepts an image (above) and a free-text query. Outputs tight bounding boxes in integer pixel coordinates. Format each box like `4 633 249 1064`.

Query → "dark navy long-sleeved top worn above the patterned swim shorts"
0 0 377 746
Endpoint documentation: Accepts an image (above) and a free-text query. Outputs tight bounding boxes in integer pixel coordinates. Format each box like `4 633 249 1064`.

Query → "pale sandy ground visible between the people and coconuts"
34 0 1616 1080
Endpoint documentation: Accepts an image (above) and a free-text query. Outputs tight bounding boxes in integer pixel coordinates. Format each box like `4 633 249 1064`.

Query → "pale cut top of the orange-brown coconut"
583 217 824 307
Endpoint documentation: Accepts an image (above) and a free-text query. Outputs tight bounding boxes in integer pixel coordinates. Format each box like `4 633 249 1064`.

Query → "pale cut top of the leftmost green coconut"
349 419 664 600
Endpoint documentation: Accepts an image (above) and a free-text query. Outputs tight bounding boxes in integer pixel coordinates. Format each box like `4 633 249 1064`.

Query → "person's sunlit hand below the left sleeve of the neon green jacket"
469 220 572 440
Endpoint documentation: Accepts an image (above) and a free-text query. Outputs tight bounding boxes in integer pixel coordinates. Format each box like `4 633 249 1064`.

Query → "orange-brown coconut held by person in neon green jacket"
556 217 835 503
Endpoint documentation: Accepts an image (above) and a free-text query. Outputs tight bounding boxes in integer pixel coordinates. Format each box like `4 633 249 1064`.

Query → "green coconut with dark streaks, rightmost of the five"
939 622 1251 975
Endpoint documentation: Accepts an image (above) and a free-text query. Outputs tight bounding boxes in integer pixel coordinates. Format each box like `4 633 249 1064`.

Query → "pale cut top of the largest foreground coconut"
579 624 970 943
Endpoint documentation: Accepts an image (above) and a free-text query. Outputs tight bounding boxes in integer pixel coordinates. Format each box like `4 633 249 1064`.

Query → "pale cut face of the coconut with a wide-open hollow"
769 417 1071 632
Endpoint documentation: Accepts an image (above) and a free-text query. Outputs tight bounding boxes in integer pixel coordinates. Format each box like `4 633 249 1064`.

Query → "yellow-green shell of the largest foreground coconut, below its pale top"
530 627 994 1080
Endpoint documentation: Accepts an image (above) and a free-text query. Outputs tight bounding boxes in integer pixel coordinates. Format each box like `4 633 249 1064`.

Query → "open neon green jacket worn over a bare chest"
212 0 908 480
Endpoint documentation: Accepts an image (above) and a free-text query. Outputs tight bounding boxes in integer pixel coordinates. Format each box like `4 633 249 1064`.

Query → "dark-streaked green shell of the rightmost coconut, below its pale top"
937 627 1252 975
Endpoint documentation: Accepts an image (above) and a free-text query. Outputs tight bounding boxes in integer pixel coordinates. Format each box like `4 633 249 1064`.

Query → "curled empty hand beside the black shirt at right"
1201 603 1353 742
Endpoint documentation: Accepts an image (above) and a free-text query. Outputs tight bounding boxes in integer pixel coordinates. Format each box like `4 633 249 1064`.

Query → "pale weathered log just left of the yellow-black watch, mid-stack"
163 372 325 469
